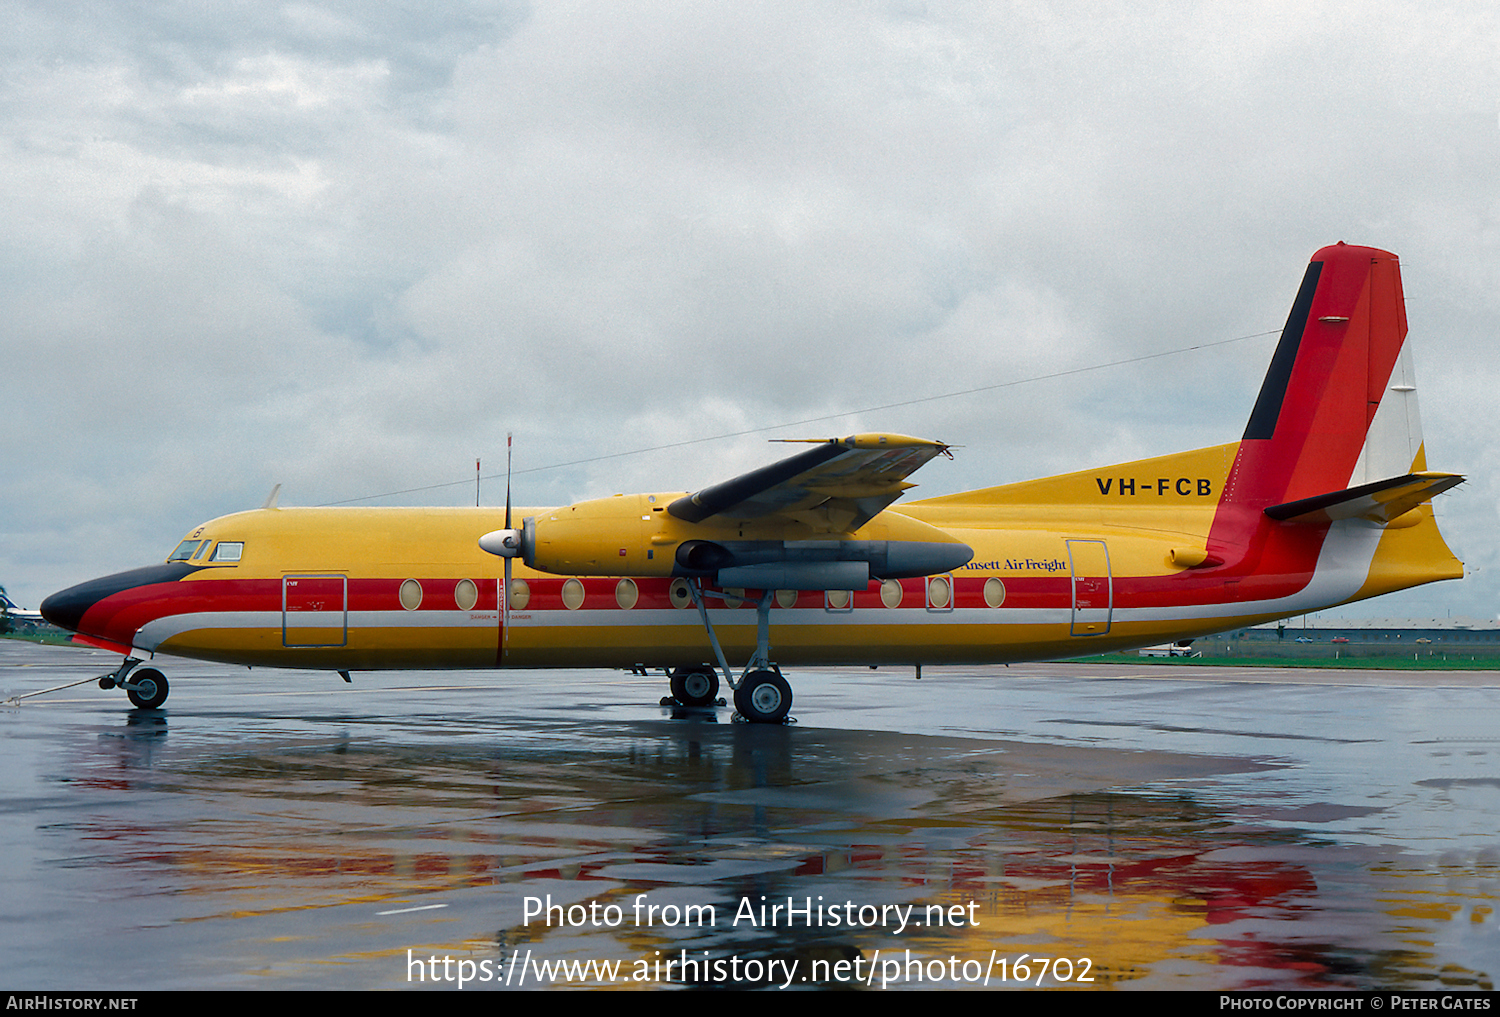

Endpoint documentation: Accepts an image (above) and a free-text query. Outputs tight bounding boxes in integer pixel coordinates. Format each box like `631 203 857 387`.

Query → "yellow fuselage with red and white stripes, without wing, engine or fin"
90 444 1463 669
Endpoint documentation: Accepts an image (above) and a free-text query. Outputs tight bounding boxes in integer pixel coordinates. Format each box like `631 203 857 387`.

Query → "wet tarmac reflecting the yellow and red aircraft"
0 641 1500 992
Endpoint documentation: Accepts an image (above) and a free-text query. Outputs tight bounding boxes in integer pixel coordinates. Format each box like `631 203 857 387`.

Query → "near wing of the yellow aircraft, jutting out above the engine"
666 434 953 533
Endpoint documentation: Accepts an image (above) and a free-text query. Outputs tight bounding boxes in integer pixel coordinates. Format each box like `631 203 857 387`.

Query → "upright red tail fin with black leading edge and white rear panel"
1226 243 1427 509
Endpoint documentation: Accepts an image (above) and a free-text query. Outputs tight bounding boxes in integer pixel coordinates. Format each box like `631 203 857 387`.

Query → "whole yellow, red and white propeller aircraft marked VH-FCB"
42 243 1463 723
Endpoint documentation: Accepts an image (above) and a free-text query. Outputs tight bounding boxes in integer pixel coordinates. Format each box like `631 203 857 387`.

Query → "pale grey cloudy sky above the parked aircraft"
0 0 1500 618
